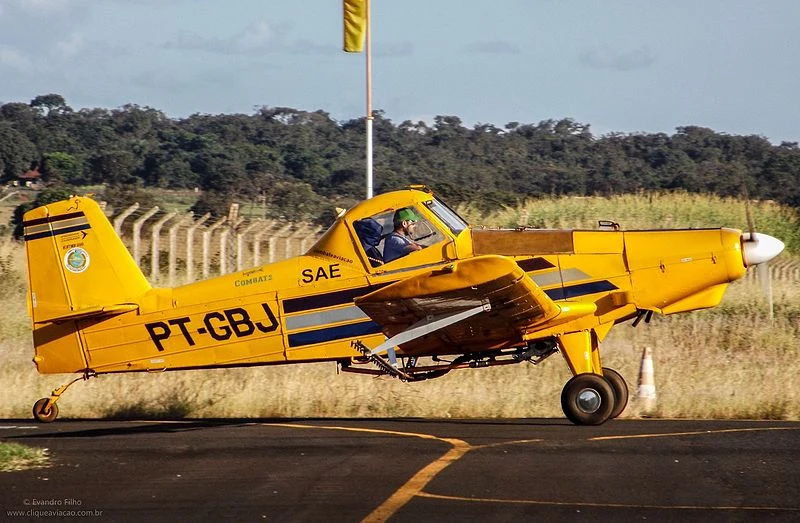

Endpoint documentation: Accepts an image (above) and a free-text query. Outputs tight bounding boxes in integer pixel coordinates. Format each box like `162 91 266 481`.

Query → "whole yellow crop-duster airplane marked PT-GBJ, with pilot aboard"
24 186 784 425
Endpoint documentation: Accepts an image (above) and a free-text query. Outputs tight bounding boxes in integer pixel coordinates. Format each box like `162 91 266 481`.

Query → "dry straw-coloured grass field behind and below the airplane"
0 195 800 419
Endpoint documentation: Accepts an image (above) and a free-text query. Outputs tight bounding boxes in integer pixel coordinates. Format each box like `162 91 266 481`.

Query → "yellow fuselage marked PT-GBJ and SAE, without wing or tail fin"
28 190 780 373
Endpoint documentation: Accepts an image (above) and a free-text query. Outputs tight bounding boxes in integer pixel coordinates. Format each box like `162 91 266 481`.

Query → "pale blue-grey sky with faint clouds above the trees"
0 0 800 144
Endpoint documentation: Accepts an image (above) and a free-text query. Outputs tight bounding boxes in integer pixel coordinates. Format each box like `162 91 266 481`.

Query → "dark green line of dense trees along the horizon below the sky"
0 94 800 220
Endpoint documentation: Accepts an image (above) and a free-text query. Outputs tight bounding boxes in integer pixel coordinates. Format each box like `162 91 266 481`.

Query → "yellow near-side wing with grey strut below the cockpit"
355 255 561 354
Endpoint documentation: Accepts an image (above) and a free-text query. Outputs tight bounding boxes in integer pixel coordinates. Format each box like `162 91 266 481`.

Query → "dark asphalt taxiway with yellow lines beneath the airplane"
0 419 800 523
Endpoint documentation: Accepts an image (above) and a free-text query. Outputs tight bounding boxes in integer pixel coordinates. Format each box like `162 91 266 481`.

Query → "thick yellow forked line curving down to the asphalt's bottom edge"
265 423 542 522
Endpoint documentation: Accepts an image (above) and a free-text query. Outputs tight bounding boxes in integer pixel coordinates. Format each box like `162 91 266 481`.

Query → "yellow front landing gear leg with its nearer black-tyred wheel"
556 330 616 425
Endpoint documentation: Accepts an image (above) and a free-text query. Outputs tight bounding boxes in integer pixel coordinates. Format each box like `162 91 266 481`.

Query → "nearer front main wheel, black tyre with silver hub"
561 373 614 425
